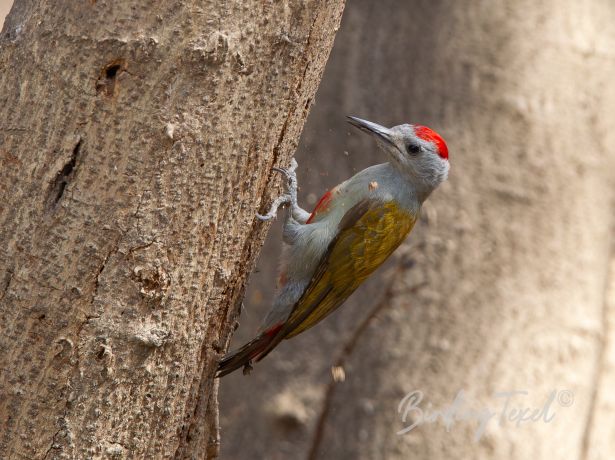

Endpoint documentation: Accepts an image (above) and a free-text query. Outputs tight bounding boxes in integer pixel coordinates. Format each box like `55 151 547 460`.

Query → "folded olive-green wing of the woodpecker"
258 199 416 360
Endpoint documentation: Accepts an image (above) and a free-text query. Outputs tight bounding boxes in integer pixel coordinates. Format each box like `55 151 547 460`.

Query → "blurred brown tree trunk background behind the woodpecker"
221 0 615 460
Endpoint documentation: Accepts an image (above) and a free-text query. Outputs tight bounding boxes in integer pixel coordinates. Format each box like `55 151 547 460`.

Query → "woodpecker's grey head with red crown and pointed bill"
348 117 449 194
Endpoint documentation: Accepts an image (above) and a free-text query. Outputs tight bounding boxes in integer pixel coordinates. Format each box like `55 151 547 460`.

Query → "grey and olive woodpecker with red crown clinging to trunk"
216 117 449 377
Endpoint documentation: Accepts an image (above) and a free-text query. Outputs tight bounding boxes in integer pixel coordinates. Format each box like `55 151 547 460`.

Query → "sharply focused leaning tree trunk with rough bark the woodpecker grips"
0 0 343 458
